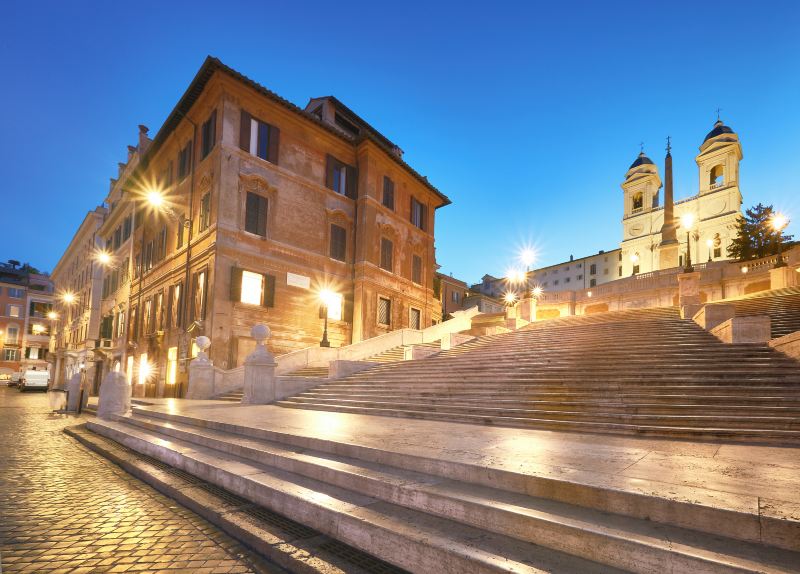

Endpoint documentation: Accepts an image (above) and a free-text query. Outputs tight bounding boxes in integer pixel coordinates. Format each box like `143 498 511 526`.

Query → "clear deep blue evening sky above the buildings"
0 0 800 282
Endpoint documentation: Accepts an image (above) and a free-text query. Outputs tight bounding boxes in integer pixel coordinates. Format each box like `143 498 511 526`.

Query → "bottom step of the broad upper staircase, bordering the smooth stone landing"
276 400 800 444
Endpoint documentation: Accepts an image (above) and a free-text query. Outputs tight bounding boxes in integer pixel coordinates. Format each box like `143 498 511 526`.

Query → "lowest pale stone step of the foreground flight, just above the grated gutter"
87 421 624 574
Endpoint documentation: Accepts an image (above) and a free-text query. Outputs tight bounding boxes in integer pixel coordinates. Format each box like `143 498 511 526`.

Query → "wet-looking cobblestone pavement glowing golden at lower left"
0 385 281 574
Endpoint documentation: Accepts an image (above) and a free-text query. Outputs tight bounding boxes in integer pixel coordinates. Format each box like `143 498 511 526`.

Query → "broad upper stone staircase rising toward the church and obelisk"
278 308 800 443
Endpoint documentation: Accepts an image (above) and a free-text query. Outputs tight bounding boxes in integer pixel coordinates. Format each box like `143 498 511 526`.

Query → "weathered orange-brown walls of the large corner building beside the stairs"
54 59 446 396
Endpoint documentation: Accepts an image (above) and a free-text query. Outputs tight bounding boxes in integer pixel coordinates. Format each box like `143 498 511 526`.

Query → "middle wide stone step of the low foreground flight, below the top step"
87 414 798 572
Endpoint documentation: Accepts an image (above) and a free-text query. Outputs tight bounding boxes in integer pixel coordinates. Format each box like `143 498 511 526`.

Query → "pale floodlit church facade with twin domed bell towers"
619 120 742 277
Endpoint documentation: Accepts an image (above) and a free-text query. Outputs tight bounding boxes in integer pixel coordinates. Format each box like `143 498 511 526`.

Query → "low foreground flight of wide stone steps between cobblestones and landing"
87 410 800 574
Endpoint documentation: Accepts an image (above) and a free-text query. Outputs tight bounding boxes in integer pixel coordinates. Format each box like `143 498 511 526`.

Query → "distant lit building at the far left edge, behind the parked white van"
0 261 53 378
